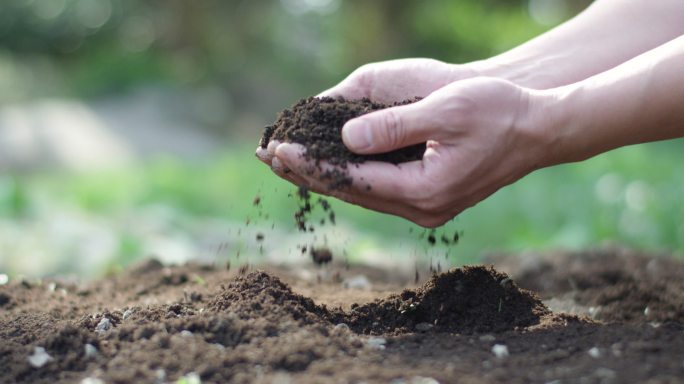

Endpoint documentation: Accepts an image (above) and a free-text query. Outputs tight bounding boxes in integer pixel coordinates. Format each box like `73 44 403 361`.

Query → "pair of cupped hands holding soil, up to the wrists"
256 59 548 227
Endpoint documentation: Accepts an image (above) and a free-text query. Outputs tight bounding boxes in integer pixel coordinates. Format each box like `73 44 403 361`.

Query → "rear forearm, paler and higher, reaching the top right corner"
470 0 684 89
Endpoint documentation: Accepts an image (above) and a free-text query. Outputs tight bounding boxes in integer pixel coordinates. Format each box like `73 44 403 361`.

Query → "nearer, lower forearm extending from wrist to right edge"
533 35 684 165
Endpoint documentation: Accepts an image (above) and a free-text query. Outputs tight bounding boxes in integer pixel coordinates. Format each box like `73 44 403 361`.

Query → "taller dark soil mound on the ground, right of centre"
347 266 551 334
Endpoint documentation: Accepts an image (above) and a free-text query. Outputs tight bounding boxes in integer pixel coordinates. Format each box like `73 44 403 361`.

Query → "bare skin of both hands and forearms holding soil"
257 0 684 227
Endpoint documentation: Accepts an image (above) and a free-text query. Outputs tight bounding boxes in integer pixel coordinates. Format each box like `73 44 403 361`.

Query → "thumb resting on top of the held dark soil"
342 102 430 154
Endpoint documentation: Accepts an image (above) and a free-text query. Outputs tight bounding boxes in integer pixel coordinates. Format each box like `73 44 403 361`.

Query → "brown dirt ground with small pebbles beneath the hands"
0 249 684 384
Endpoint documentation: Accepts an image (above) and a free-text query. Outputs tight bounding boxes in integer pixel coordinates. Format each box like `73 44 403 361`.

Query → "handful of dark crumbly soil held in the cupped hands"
260 97 425 172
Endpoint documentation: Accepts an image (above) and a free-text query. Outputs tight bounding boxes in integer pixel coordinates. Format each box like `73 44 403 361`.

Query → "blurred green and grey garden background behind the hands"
0 0 684 276
